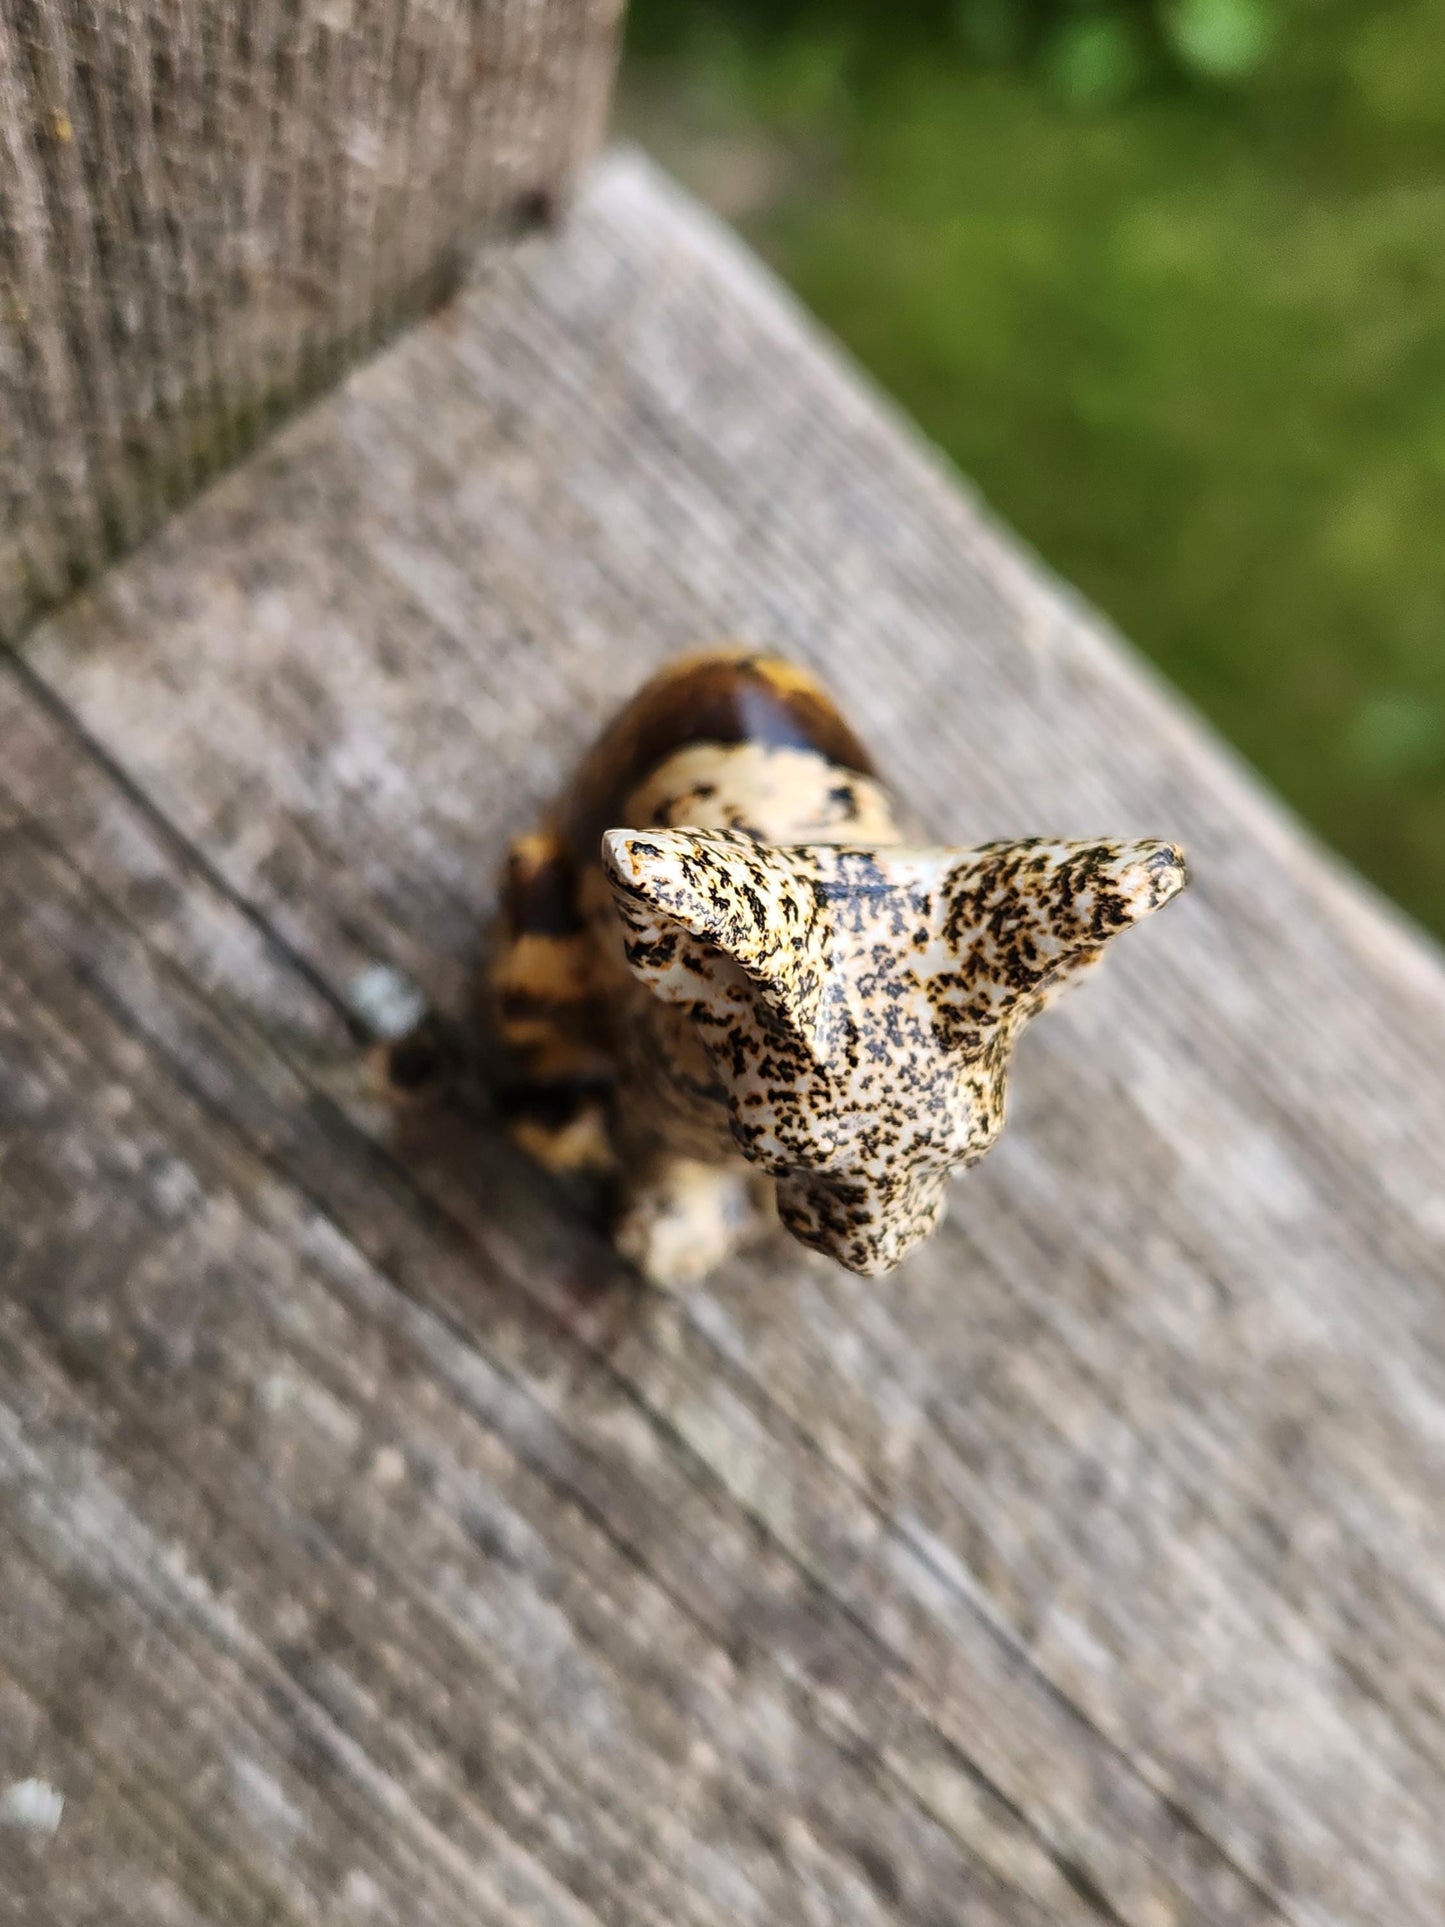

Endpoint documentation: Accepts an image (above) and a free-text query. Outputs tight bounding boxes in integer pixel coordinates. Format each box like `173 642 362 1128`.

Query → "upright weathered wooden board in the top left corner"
0 0 620 640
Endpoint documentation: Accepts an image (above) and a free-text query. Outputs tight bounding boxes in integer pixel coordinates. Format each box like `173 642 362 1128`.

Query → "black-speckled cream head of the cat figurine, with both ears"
603 829 1187 1276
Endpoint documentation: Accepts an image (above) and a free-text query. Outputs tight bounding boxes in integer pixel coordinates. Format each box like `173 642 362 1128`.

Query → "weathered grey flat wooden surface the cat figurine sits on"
0 156 1445 1927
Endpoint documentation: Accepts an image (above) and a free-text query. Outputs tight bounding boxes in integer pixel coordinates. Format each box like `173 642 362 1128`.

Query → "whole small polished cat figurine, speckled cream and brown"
491 651 1185 1283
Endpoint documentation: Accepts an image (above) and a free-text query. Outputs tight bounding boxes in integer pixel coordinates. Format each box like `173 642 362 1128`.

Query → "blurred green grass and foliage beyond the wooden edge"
624 0 1445 933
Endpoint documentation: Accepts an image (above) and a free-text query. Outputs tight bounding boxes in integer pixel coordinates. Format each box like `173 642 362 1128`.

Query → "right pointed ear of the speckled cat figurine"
931 838 1189 1050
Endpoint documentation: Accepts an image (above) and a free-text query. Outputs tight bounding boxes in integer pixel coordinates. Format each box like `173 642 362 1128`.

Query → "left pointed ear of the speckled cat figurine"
603 831 827 1044
